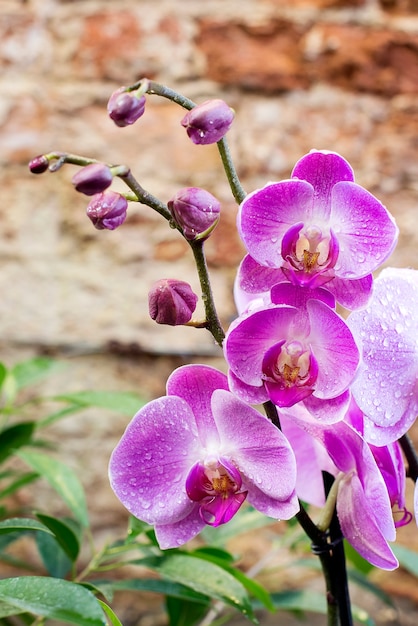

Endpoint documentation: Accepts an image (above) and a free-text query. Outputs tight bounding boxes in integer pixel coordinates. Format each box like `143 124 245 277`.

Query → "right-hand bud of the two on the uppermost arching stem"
181 99 235 145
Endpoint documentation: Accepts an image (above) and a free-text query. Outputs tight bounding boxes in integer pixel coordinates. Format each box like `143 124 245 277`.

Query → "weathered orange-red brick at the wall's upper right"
197 19 418 96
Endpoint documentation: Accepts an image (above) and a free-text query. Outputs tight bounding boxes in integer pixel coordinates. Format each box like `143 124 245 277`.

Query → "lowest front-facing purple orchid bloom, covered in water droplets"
109 365 299 549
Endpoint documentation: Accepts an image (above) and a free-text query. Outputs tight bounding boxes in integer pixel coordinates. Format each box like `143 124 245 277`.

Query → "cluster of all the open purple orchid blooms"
110 146 418 569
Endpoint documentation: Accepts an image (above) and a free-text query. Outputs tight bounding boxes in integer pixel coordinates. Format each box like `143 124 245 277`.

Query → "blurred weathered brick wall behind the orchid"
0 0 418 624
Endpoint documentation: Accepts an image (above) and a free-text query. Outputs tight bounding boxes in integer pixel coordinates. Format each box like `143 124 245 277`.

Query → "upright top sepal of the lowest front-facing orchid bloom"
167 365 228 445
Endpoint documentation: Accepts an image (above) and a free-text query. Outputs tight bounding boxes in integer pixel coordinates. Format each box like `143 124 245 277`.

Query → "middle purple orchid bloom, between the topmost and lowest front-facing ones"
224 283 359 423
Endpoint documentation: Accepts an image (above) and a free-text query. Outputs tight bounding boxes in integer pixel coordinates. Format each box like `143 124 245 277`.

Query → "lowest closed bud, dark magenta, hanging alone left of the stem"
148 278 198 326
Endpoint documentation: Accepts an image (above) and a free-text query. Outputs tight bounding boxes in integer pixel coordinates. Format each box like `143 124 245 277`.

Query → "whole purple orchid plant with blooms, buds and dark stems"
4 79 418 626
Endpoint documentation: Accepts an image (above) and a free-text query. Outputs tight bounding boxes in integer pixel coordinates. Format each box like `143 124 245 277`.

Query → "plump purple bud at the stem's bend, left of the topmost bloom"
167 187 221 241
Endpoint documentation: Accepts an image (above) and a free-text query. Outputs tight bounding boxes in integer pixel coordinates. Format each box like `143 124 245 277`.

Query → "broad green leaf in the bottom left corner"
0 576 106 626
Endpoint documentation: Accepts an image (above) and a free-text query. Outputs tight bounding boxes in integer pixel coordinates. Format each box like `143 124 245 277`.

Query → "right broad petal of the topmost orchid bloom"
330 182 399 279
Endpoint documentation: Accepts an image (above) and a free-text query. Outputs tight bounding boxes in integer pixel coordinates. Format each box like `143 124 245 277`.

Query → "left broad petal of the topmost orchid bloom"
238 180 314 268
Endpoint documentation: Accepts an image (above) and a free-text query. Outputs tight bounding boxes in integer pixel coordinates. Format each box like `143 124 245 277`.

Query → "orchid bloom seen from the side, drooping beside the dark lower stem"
280 405 398 570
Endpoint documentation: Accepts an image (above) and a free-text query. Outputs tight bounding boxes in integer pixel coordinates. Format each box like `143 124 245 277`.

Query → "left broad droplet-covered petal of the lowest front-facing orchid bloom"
109 397 201 524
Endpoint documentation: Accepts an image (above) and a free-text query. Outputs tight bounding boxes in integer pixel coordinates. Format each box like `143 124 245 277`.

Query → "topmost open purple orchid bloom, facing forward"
238 151 398 308
